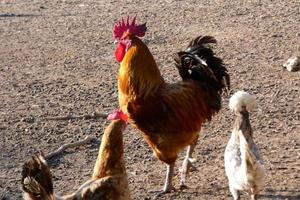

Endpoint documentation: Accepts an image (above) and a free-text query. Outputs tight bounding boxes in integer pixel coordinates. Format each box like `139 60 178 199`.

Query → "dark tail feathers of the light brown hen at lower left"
22 154 54 200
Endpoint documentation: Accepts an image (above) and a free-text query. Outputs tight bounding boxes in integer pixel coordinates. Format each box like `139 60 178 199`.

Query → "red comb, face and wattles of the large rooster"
113 16 147 62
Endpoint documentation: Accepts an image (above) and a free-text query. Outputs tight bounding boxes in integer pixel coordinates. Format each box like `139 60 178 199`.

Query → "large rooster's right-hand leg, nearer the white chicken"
180 135 199 189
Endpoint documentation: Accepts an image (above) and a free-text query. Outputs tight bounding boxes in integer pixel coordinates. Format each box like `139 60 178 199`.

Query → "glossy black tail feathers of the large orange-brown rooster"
175 36 230 93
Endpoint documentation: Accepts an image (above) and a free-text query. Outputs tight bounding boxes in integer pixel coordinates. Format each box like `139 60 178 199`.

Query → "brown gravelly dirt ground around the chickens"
0 0 300 200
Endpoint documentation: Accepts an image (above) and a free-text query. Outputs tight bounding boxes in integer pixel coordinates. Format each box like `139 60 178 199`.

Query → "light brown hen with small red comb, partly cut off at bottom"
22 111 131 200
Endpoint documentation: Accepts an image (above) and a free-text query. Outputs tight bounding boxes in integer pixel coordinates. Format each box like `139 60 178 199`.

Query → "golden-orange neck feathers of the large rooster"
118 36 163 99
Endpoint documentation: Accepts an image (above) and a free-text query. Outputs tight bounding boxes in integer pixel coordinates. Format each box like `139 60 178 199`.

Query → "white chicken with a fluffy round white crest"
224 91 265 200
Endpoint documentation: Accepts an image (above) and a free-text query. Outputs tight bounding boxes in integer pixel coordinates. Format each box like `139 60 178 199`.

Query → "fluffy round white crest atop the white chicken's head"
229 90 257 113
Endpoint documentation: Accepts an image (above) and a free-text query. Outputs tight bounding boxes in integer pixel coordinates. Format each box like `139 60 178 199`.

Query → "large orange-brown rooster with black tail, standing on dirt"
113 17 229 193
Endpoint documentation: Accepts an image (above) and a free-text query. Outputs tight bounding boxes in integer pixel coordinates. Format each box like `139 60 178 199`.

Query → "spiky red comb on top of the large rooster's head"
113 16 147 40
